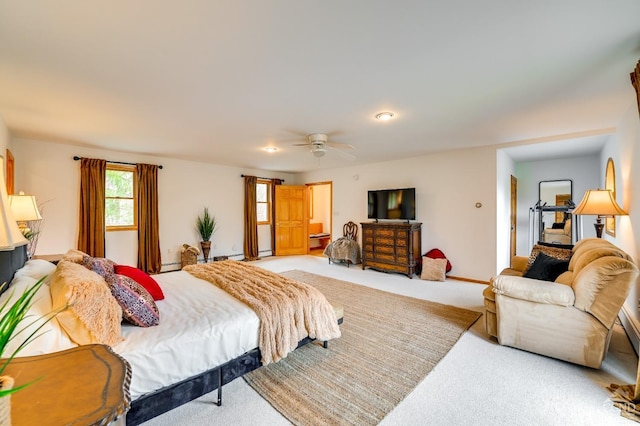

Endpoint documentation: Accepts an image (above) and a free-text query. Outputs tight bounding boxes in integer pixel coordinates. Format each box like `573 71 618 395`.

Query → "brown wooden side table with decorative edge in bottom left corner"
4 345 131 426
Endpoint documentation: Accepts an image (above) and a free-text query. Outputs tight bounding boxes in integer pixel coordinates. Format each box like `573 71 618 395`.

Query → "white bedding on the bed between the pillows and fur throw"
113 271 260 400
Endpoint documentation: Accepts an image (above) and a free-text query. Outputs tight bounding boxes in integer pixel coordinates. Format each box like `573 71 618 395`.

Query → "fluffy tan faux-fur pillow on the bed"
49 260 122 346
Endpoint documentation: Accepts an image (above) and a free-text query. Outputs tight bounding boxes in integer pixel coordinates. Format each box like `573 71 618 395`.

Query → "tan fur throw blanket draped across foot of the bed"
184 260 340 365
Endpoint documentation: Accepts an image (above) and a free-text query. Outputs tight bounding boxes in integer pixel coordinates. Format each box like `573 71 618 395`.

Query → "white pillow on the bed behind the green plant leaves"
0 272 77 357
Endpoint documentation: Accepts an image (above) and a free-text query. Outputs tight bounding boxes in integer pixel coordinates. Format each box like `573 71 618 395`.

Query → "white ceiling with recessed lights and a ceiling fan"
0 0 640 172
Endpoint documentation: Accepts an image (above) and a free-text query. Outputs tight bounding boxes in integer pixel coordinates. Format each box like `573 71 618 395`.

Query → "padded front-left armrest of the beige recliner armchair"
491 275 576 306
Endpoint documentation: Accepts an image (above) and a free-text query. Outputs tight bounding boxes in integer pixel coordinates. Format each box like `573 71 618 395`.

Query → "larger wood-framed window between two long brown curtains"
105 164 138 231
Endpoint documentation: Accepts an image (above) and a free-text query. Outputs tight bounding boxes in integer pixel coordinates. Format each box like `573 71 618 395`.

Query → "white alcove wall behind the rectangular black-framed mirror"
514 155 604 256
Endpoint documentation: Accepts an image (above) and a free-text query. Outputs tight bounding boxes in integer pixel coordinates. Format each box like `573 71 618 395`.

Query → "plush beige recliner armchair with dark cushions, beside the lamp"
484 238 638 368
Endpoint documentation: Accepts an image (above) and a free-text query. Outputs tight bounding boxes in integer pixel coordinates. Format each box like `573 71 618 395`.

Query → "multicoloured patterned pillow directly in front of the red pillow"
105 274 160 327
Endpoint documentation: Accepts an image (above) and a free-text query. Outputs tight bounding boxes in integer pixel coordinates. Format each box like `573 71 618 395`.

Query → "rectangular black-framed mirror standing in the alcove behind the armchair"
536 179 575 244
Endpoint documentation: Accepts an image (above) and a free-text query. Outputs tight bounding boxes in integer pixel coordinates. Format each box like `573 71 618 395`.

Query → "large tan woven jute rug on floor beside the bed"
244 271 481 425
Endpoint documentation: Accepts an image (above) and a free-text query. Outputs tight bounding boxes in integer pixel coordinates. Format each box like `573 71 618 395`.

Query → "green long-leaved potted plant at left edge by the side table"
0 277 57 424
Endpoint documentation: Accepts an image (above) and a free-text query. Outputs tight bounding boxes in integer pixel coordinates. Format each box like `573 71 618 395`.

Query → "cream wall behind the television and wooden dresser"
297 147 496 281
